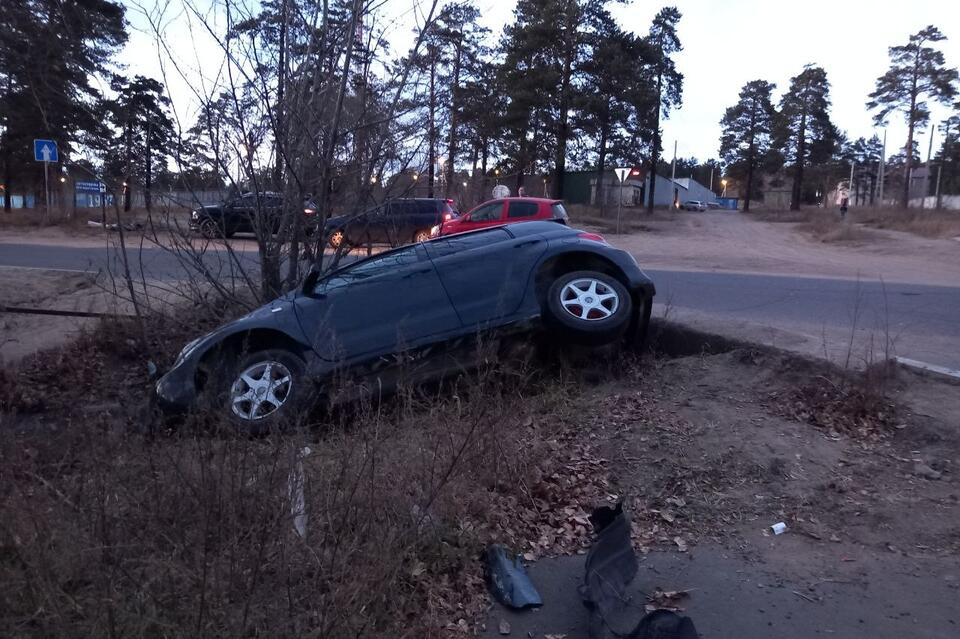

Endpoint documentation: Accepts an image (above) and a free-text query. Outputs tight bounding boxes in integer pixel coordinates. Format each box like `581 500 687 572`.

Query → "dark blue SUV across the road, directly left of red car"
324 198 458 248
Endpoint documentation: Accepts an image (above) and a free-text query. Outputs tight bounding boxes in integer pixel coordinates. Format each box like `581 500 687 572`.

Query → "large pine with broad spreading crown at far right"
867 25 958 208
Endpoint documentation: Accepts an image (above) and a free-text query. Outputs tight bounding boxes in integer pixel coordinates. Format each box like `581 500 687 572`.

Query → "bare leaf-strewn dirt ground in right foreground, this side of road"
483 338 960 639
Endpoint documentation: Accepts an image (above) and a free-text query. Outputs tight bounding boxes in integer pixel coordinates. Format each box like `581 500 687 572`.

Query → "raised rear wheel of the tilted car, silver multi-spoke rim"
546 271 633 345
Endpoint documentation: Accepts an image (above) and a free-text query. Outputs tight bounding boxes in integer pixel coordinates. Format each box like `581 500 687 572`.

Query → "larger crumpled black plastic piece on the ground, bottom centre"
580 502 699 639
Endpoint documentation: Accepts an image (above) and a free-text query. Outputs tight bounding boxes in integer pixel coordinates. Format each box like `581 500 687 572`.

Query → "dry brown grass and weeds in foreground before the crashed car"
0 312 605 638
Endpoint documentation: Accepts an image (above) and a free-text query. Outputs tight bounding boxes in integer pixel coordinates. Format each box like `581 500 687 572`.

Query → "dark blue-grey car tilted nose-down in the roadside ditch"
156 222 655 433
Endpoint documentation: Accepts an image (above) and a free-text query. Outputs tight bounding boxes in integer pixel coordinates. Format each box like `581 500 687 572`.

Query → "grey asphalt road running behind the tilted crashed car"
0 243 960 369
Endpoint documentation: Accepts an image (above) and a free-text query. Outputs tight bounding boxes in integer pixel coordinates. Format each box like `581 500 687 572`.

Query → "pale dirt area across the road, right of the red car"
588 211 960 286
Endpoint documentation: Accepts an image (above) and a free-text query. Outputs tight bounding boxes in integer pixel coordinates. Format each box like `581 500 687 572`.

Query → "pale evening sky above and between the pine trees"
121 0 960 165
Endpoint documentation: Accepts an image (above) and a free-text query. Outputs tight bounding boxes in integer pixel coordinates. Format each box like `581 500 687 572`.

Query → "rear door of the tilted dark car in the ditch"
424 228 547 327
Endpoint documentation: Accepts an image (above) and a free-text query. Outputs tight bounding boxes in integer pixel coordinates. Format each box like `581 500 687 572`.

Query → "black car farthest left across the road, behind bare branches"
190 191 317 238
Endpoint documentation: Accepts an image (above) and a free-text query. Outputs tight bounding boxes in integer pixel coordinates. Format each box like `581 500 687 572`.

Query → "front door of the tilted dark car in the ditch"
297 245 460 361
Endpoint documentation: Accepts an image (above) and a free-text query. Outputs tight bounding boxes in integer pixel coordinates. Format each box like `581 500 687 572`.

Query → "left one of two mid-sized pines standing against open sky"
720 80 776 211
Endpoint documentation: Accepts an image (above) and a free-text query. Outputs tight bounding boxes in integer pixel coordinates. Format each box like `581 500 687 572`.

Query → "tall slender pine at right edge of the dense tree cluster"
647 7 683 213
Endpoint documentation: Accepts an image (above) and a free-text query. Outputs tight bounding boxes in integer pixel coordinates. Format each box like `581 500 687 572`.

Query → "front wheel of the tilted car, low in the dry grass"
212 349 313 435
